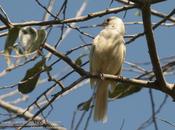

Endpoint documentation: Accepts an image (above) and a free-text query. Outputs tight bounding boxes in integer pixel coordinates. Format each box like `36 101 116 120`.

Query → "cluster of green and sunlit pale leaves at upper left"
4 26 47 67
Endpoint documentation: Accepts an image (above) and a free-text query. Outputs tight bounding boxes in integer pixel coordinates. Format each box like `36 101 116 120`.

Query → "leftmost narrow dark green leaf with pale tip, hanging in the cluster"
4 26 20 66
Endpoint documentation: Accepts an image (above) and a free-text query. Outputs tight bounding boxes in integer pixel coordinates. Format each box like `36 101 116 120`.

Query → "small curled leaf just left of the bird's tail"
77 98 92 111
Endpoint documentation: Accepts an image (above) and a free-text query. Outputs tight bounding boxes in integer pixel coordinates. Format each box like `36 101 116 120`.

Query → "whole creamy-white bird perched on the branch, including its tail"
90 17 126 122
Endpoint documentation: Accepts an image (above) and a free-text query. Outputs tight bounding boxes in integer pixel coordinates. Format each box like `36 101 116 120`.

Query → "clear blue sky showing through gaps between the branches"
0 0 175 130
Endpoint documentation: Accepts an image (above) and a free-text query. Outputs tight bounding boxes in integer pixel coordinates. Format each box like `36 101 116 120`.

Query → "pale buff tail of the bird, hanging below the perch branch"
94 80 109 123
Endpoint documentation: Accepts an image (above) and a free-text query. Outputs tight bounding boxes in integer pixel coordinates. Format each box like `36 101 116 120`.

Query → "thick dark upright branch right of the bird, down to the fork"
142 0 166 88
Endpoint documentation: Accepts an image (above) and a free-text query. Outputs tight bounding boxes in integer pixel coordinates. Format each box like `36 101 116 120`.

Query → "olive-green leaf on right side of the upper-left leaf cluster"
28 29 47 53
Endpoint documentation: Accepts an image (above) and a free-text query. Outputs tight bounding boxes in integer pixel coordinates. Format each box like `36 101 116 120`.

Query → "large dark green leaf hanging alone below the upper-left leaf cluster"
18 60 45 94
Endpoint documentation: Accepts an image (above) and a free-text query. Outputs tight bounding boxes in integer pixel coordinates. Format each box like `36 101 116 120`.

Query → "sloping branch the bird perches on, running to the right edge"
44 44 175 100
